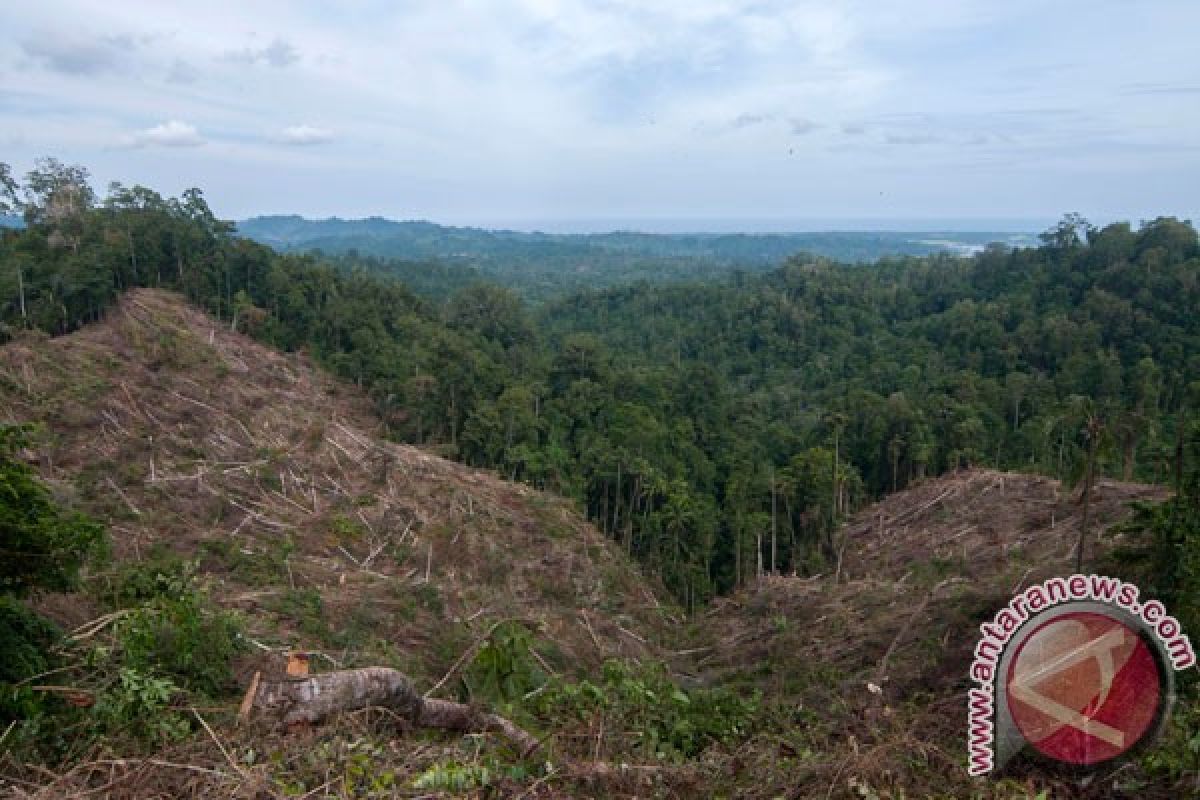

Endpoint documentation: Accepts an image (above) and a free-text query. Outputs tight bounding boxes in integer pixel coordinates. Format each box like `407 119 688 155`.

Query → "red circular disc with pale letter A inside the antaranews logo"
1007 612 1163 765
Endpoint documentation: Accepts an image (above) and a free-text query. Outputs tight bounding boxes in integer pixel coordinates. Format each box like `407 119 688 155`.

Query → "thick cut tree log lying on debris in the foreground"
242 667 540 756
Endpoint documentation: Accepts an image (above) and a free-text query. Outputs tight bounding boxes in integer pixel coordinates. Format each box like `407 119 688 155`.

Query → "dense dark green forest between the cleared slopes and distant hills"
0 160 1200 606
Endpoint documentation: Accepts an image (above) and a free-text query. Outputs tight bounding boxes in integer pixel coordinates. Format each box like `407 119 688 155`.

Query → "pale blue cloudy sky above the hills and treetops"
0 0 1200 230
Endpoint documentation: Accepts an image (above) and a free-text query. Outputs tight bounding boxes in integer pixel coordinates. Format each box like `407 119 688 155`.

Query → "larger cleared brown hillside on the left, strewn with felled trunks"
0 289 667 679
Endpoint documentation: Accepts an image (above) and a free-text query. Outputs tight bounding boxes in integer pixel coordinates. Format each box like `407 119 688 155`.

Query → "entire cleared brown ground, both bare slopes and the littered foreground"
0 296 1190 799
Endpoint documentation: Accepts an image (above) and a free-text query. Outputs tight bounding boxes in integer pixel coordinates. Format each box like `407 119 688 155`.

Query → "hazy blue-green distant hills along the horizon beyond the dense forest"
238 215 1033 299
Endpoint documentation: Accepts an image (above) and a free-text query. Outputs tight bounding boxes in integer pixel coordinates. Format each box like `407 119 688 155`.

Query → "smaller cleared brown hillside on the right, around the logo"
680 469 1174 798
